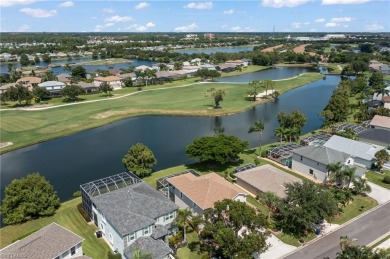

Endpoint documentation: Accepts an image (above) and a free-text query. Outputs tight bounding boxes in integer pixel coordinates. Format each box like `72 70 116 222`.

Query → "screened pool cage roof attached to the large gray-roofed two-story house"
80 172 142 197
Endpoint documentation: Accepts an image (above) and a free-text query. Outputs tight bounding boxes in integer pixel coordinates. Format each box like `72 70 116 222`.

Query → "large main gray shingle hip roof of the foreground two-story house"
91 182 178 236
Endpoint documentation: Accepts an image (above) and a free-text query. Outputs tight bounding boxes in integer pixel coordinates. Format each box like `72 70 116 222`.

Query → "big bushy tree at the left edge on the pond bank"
0 173 60 224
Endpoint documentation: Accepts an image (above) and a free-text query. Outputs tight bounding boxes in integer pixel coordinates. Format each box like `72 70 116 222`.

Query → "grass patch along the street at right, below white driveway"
330 195 378 224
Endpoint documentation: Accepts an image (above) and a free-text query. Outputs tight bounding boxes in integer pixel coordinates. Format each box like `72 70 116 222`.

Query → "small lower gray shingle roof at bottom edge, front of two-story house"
124 237 173 259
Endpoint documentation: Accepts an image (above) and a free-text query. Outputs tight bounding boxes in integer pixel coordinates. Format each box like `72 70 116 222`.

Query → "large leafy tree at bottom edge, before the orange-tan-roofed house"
199 200 270 258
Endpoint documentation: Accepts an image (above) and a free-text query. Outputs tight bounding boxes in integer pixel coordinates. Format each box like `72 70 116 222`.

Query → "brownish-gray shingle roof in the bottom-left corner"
0 223 84 259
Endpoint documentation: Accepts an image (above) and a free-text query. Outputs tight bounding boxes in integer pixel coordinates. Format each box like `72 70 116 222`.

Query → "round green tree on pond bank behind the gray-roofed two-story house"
122 143 157 177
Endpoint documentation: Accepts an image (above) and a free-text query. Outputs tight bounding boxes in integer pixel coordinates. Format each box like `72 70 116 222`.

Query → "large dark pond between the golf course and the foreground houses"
0 73 340 200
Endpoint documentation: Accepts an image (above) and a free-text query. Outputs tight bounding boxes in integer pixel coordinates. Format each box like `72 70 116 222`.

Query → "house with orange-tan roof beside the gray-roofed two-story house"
166 172 247 214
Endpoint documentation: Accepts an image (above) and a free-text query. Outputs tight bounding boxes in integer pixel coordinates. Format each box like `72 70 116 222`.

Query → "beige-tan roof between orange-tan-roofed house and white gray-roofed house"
235 165 302 198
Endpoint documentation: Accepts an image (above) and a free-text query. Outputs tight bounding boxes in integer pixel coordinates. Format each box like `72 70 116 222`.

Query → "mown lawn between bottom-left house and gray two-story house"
0 198 111 258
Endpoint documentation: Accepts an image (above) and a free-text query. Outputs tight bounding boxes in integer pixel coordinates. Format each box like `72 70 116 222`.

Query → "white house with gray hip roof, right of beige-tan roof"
291 146 354 182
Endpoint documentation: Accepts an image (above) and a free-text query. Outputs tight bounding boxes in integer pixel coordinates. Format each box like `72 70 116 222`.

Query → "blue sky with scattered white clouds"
0 0 390 32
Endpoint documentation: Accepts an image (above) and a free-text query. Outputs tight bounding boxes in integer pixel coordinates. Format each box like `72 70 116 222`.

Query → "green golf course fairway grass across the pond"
0 73 323 153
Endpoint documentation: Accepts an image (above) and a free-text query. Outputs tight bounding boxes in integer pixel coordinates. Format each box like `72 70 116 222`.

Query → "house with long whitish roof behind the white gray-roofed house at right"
324 135 384 169
